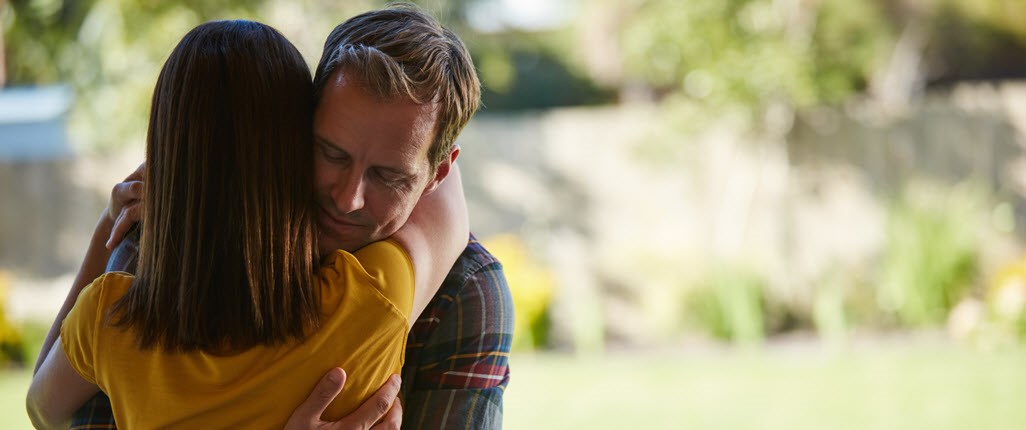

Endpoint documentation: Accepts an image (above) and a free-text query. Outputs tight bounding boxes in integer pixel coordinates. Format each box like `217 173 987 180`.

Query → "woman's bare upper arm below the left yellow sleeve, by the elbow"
26 337 100 429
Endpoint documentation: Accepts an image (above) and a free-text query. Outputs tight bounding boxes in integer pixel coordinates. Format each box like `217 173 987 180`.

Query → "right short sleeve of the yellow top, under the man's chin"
353 239 413 319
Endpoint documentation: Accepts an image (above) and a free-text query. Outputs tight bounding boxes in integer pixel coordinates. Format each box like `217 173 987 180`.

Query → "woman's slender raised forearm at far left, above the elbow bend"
33 209 114 374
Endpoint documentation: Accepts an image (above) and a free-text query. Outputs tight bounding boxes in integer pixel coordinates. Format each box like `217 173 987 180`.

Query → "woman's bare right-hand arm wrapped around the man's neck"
392 162 470 325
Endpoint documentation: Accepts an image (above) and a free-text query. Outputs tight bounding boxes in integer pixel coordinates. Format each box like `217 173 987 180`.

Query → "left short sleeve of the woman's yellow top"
61 274 107 384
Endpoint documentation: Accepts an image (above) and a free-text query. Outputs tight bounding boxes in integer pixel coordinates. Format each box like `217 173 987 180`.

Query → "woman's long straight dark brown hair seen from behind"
116 21 318 350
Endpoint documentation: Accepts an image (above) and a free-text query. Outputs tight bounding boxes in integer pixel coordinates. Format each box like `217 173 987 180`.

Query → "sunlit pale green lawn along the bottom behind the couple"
6 345 1026 430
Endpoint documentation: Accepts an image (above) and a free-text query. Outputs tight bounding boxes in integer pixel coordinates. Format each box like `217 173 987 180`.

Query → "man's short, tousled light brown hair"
314 3 481 168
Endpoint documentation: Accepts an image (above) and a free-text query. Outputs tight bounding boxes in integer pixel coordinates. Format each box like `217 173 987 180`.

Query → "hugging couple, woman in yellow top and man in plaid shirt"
27 4 513 429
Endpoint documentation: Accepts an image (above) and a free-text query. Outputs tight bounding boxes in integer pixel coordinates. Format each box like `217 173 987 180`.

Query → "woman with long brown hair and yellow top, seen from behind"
28 21 468 428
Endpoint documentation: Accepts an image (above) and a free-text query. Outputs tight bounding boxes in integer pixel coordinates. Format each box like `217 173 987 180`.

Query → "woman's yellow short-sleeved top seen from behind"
61 241 413 429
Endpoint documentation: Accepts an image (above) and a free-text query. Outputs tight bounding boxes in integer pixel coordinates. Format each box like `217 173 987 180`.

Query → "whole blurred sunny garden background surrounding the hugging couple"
0 0 1026 429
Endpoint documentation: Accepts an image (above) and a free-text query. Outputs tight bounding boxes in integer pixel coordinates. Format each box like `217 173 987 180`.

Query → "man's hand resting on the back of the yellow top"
285 367 402 430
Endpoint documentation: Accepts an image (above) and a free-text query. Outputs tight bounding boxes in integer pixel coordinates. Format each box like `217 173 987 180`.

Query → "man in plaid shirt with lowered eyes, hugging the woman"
48 5 513 429
